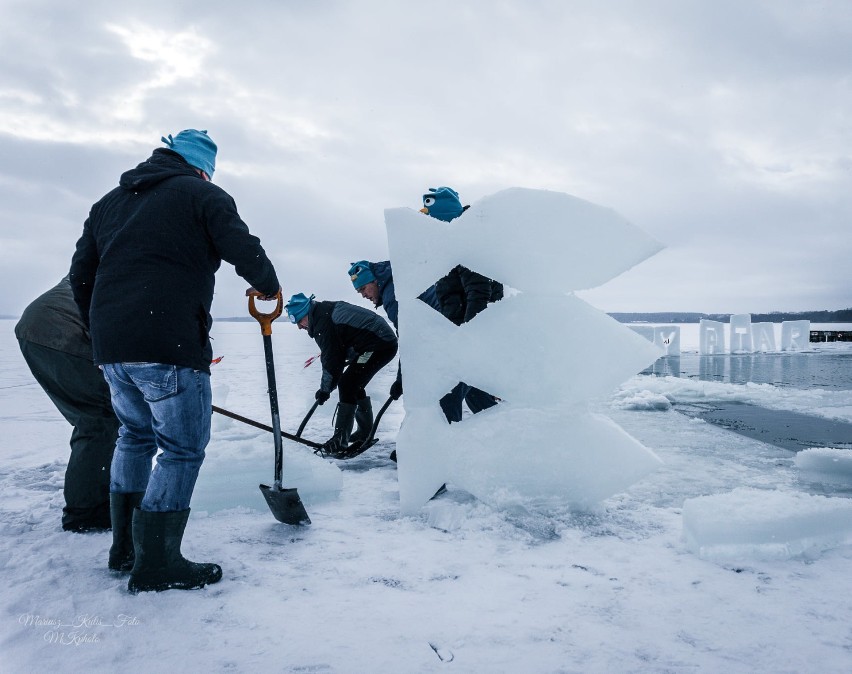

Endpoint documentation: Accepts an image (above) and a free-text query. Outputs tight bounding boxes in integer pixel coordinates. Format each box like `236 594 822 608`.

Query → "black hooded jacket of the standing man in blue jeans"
70 148 280 372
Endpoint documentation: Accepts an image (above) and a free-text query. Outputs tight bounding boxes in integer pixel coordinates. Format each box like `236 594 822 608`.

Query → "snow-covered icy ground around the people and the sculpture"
0 320 852 673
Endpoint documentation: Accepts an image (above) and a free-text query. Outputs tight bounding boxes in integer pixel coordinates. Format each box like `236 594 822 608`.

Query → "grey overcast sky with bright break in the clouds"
0 0 852 317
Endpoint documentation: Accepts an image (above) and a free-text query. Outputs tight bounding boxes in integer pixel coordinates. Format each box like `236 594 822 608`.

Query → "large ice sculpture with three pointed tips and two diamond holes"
385 188 662 514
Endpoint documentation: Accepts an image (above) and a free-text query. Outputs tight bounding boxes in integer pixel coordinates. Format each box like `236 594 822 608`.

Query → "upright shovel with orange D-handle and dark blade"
249 290 311 524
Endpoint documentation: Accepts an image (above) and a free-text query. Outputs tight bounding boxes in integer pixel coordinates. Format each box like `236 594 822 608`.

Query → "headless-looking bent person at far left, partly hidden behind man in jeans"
15 276 120 532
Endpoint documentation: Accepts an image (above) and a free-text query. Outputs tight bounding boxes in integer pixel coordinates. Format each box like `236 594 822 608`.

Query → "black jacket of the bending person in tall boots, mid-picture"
308 302 396 393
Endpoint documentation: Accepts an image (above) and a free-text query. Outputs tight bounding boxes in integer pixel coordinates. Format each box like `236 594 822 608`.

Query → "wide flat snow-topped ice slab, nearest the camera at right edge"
683 488 852 560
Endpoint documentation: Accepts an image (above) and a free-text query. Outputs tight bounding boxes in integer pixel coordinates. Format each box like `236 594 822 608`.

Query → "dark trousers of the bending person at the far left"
19 340 119 531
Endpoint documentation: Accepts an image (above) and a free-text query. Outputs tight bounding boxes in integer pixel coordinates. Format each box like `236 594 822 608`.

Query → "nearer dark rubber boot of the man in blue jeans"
127 508 222 594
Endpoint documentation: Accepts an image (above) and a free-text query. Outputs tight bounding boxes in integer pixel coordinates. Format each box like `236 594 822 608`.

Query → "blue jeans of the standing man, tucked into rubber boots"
103 363 213 512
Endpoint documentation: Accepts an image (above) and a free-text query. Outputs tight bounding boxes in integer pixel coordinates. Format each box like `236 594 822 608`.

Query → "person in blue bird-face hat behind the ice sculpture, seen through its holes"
420 187 503 423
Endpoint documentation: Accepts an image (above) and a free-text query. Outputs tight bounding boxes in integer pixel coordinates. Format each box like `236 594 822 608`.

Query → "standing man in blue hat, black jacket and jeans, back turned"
70 129 280 592
